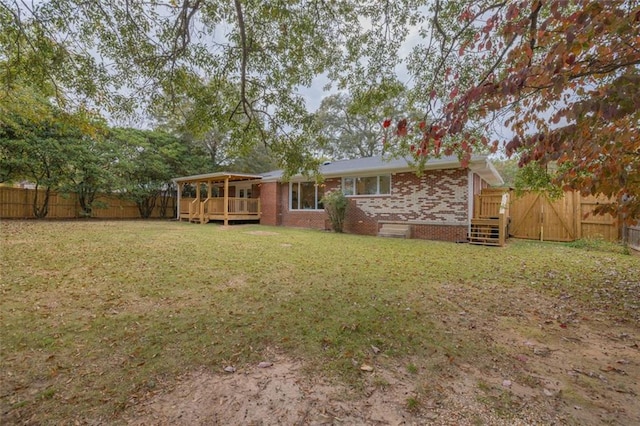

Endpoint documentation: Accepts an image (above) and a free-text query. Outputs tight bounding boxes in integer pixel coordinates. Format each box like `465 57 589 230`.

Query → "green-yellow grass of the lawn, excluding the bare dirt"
0 221 640 423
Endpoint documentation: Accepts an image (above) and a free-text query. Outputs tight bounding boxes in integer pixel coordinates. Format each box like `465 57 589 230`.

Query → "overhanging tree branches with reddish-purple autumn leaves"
398 0 640 221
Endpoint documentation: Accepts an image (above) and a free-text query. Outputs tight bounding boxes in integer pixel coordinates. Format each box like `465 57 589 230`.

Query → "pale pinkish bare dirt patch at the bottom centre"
125 359 407 425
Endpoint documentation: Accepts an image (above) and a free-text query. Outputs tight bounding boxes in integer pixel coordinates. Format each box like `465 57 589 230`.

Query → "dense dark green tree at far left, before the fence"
0 86 105 218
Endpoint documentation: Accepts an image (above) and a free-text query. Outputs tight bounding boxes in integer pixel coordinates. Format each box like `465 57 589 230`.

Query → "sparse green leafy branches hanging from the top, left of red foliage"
0 0 416 177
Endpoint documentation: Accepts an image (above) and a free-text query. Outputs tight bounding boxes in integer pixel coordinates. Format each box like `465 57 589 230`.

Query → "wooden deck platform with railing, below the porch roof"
180 197 261 223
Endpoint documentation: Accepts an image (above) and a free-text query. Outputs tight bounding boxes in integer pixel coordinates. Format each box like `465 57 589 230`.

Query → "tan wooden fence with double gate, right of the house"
509 192 620 241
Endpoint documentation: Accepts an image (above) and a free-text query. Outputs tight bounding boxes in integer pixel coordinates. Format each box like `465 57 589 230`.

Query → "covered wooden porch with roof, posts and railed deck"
173 172 262 225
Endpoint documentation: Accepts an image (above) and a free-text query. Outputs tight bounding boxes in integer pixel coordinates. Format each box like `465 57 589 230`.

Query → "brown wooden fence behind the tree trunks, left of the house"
0 187 175 219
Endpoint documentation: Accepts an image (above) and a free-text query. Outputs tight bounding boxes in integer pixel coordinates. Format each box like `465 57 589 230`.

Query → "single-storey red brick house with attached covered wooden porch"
174 156 502 241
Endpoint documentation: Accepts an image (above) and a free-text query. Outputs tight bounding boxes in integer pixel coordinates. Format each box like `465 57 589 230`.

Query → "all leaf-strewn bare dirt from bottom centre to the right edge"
125 285 640 426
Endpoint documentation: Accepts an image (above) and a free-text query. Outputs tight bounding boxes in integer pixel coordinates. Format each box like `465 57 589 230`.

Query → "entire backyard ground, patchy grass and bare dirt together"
0 221 640 425
